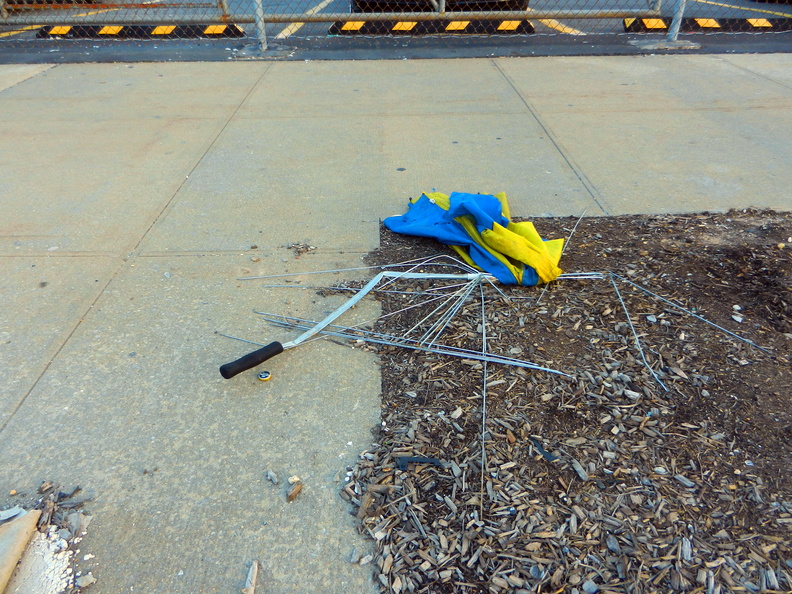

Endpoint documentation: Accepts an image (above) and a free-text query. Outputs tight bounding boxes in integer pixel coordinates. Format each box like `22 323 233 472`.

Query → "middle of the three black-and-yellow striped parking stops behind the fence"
329 19 534 35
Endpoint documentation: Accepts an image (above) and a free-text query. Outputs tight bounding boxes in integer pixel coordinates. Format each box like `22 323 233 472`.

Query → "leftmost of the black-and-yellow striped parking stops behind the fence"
36 25 245 39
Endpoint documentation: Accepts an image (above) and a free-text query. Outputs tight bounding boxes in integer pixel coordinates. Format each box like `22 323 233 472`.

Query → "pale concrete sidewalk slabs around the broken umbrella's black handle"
0 54 792 593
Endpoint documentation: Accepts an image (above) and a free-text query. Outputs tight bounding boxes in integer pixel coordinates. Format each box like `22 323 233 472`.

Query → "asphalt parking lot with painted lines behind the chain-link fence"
0 0 792 61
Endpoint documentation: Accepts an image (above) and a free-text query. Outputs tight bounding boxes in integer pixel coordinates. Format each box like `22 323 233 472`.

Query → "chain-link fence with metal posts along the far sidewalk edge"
0 0 792 51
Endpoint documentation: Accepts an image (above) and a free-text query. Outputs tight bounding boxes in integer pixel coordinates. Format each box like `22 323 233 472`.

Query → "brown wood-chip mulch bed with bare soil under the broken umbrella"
341 210 792 594
